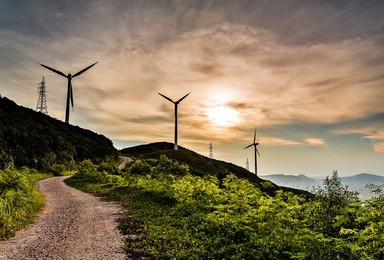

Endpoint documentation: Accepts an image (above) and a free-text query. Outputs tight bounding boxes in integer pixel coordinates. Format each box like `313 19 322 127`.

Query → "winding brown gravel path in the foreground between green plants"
0 177 125 260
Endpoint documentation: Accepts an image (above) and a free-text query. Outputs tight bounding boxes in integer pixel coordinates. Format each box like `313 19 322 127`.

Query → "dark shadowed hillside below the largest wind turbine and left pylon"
0 97 117 169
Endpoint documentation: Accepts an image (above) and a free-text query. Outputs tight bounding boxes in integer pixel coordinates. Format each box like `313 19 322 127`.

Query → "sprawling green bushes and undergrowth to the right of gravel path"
68 156 384 259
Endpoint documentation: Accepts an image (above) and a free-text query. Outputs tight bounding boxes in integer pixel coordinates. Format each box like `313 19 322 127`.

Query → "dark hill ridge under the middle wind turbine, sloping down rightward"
120 142 310 195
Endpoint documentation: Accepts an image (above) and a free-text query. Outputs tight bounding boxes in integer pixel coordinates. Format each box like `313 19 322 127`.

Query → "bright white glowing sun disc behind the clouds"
207 106 240 126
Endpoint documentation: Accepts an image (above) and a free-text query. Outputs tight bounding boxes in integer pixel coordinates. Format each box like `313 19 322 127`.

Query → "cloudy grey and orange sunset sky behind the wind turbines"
0 0 384 176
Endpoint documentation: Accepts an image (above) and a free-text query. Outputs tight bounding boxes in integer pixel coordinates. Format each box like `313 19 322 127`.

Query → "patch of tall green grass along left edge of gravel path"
0 167 50 240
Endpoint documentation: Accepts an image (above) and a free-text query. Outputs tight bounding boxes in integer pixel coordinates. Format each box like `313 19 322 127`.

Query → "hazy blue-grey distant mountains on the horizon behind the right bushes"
260 173 384 200
